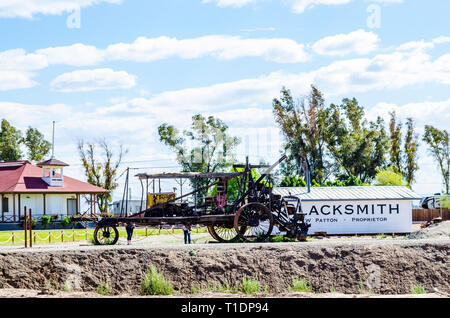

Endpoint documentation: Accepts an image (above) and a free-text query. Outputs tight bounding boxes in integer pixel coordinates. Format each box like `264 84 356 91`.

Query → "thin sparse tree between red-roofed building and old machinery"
78 140 127 212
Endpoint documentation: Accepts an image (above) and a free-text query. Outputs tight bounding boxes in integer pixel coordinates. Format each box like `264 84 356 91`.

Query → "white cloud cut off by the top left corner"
0 0 122 19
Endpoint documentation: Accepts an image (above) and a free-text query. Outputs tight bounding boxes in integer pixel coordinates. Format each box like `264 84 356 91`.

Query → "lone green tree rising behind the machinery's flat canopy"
158 114 240 198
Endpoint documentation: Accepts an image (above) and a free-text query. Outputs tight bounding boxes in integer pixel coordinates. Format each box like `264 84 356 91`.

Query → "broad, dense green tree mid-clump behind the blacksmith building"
326 98 389 183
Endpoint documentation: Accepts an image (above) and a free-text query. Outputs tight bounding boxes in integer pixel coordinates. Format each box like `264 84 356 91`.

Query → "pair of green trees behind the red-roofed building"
0 119 52 162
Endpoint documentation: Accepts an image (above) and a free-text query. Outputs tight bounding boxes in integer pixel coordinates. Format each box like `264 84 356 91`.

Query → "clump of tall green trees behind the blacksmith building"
273 86 418 185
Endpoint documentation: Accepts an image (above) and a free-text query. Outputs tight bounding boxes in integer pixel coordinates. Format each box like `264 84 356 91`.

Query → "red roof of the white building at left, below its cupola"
0 161 108 193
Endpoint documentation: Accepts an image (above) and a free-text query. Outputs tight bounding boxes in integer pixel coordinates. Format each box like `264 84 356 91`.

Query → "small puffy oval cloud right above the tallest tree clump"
312 30 380 56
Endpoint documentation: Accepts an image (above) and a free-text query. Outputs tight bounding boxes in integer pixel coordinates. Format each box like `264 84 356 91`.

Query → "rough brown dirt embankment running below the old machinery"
0 240 450 295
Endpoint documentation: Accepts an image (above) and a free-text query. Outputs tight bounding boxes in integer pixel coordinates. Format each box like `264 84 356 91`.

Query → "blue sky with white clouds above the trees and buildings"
0 0 450 197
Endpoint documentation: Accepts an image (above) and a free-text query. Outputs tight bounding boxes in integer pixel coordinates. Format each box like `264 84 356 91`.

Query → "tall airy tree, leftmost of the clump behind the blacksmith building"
272 85 332 184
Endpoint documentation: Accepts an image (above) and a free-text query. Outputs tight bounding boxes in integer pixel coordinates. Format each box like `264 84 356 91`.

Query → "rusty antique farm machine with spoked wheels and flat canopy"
76 156 310 244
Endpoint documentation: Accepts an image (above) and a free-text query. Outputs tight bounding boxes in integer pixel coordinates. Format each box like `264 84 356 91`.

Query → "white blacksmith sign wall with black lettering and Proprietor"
302 200 412 234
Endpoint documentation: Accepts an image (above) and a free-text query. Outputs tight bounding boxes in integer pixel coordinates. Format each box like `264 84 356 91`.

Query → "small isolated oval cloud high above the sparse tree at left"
50 68 136 92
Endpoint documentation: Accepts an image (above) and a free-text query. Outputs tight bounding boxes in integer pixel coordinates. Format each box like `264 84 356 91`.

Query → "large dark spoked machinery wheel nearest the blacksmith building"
234 202 273 242
